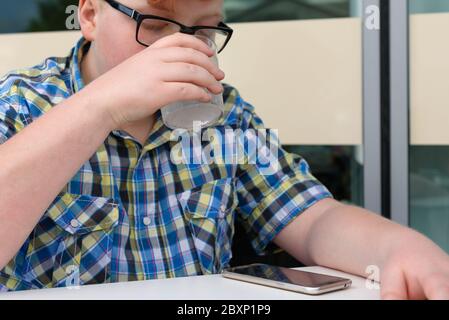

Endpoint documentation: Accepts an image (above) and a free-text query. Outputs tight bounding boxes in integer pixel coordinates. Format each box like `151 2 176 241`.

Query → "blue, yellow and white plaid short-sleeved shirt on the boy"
0 39 331 291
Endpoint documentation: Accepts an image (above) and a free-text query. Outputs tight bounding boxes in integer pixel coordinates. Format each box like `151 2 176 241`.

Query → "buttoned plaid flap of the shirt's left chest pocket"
45 193 119 234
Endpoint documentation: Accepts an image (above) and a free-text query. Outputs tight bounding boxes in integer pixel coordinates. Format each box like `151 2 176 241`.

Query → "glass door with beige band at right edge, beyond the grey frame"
409 0 449 252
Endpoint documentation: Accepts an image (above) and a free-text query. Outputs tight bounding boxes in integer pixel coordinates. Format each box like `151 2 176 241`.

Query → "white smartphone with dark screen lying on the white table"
222 263 352 295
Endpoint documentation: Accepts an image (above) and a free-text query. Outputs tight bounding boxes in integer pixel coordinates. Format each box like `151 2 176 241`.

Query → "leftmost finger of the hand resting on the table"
380 268 408 300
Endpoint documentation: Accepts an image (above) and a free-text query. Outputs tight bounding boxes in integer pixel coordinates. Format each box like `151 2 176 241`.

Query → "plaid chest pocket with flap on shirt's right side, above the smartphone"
180 179 238 274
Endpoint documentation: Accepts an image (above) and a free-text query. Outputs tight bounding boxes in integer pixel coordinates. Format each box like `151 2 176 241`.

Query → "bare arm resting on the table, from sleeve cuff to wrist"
275 199 436 276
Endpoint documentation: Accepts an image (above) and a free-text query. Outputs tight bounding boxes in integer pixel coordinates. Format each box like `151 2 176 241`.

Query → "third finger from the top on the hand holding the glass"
162 62 223 94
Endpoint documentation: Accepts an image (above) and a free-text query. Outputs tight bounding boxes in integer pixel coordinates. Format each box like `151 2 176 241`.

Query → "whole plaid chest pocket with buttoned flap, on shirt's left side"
25 193 120 287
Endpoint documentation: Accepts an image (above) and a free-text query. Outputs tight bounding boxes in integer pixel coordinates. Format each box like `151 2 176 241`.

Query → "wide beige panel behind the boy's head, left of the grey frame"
0 18 362 145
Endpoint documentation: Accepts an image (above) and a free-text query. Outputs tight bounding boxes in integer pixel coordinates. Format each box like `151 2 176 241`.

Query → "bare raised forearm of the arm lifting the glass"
0 87 114 268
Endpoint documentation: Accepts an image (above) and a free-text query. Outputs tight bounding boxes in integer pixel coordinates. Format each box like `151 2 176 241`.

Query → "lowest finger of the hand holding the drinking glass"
163 82 211 103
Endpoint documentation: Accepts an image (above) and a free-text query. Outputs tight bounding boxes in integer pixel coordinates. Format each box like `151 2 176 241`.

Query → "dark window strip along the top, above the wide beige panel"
0 0 359 33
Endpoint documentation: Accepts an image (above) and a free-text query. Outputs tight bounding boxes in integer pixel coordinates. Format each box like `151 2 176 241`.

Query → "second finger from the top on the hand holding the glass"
158 48 225 80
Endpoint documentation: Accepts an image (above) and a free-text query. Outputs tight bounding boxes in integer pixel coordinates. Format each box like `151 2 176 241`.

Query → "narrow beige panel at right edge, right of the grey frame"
410 13 449 145
